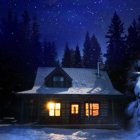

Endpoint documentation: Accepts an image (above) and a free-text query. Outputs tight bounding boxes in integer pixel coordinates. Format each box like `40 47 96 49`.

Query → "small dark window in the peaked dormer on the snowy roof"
53 76 64 87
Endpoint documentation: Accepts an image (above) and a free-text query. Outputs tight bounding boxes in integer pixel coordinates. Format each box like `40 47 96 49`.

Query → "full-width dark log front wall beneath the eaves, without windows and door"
18 94 124 125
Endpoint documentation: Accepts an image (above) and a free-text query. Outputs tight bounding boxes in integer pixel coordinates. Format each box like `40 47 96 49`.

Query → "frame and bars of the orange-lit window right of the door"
84 102 100 118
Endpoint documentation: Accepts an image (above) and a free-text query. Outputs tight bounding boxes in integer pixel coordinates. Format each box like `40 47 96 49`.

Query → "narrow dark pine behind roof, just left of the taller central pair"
74 44 82 68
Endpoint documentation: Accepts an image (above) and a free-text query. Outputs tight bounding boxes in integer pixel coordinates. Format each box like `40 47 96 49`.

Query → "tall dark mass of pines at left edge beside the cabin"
0 10 41 91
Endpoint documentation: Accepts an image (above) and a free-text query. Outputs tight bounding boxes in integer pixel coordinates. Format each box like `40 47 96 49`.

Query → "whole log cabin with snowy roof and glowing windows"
17 67 123 128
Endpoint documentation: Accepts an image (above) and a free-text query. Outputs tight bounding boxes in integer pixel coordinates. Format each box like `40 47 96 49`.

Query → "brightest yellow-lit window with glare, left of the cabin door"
47 102 61 116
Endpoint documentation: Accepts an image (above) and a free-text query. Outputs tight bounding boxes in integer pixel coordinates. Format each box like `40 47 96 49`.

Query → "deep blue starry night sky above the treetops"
0 0 140 58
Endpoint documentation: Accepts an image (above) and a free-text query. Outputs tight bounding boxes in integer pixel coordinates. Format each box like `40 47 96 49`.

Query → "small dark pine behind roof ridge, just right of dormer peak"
62 43 72 68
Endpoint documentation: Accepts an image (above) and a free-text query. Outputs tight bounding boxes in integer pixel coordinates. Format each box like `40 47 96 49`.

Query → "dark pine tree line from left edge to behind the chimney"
0 10 101 91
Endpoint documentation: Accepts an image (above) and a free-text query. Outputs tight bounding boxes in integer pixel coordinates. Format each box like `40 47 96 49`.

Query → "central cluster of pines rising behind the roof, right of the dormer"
62 32 102 68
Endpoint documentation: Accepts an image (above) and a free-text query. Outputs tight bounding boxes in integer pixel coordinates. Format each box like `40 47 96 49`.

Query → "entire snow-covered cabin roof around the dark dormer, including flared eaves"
17 67 121 95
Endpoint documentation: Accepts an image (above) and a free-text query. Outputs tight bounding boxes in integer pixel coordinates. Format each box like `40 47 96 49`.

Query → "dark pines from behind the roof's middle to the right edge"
40 12 140 93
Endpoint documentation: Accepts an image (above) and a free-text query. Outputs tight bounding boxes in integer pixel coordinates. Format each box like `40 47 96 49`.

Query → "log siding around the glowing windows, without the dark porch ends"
36 96 110 124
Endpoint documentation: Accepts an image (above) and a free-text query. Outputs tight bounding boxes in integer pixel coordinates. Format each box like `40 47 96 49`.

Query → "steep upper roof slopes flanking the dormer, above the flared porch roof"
35 68 113 88
